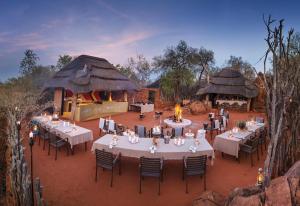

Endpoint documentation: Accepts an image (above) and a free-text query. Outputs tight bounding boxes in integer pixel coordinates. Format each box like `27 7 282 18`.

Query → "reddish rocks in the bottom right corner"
193 161 300 206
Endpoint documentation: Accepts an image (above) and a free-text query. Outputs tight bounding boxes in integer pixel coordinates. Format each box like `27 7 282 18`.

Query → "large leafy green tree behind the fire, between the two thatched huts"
153 41 195 101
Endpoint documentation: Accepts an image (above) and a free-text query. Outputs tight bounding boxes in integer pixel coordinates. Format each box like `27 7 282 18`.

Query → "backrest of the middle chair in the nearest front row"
140 157 162 175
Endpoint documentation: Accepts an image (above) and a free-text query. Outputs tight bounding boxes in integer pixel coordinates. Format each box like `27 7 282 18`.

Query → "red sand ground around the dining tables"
24 112 266 206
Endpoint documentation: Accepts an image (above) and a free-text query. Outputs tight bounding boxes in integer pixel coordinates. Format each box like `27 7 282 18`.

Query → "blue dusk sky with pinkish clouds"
0 0 300 81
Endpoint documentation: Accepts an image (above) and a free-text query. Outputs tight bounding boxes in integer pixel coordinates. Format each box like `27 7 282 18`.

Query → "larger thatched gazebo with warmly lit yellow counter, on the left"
45 55 139 121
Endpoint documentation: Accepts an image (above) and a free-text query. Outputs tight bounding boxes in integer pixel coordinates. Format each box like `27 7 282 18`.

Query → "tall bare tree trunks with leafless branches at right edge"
255 16 300 184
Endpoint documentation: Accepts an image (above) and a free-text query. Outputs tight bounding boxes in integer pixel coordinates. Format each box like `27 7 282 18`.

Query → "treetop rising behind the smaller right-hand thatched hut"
226 56 255 80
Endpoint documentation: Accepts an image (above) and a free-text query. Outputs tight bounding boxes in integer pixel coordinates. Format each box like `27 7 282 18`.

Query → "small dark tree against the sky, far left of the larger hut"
20 49 39 75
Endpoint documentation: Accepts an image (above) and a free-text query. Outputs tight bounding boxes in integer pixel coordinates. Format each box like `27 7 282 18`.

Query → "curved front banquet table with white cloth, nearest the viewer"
92 134 214 161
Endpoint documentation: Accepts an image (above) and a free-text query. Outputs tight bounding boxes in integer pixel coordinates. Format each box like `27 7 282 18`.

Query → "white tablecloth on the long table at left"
33 116 93 148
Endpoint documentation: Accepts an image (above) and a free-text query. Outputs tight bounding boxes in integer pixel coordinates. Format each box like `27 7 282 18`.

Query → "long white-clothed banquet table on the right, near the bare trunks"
213 123 264 158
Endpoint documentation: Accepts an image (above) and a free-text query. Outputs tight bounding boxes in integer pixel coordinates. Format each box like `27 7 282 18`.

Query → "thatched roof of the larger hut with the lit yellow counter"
45 55 139 93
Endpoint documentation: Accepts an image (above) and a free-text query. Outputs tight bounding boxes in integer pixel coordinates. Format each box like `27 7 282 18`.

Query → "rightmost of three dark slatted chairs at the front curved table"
182 155 207 193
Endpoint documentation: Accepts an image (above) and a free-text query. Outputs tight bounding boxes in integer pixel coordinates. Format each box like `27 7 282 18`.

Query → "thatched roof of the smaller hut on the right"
197 68 258 98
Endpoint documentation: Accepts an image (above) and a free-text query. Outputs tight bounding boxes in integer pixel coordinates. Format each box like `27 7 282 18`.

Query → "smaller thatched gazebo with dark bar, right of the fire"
197 68 258 111
